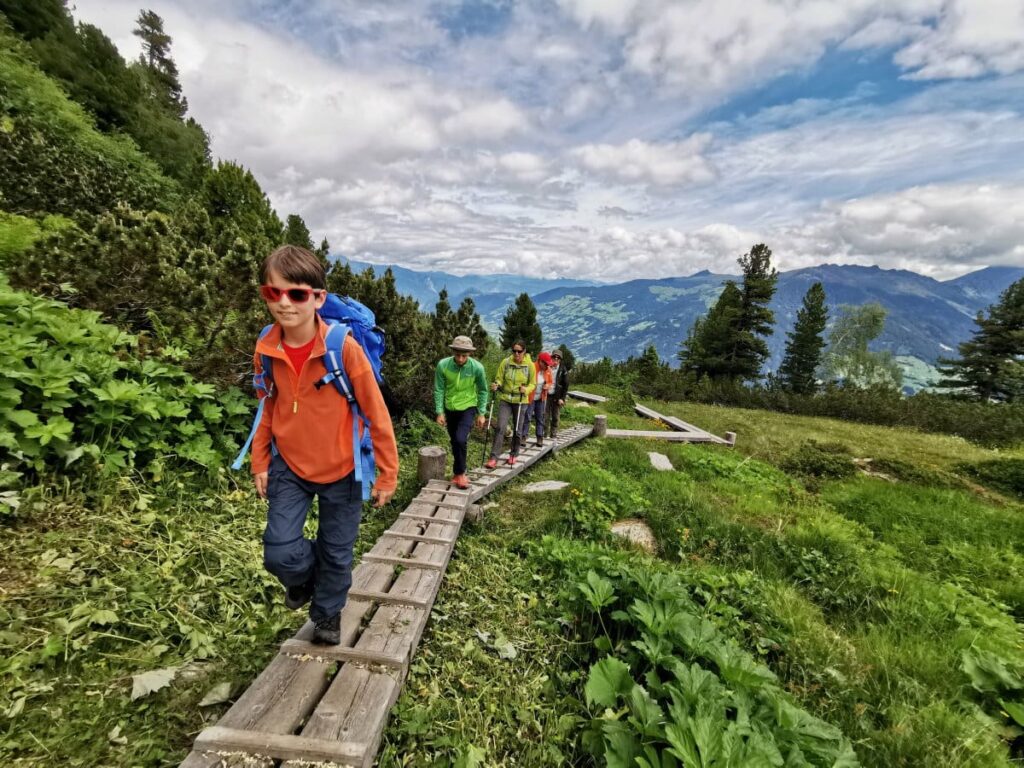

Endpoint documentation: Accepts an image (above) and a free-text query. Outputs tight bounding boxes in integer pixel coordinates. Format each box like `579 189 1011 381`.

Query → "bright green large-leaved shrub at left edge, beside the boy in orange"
0 275 250 505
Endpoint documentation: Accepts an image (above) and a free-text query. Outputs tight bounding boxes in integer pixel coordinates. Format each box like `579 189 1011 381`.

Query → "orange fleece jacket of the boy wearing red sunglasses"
252 317 398 490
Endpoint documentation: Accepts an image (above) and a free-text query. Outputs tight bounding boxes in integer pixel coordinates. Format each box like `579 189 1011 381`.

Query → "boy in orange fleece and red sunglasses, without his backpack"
252 246 398 645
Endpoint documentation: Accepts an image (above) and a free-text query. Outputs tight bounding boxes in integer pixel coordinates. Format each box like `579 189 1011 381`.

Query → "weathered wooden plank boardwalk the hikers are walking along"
181 425 593 768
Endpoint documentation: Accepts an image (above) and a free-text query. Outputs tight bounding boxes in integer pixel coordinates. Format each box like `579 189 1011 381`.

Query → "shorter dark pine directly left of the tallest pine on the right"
679 280 743 379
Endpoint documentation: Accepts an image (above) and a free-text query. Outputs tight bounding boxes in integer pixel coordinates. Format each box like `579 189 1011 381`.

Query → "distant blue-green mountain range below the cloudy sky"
339 262 1024 388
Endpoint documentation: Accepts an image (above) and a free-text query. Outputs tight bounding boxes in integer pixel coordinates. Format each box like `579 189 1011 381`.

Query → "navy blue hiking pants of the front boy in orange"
263 454 362 621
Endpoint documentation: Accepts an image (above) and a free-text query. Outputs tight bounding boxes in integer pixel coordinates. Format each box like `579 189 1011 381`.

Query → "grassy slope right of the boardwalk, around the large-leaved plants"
385 403 1024 766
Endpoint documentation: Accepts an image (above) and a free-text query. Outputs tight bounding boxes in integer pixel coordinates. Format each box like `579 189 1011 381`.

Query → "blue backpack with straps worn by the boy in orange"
231 293 384 501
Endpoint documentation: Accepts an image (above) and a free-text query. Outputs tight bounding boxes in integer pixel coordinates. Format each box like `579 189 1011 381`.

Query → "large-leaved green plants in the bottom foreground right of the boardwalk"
532 538 858 768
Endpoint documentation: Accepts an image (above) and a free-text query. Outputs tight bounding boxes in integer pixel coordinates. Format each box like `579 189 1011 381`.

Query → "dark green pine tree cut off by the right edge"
939 279 1024 402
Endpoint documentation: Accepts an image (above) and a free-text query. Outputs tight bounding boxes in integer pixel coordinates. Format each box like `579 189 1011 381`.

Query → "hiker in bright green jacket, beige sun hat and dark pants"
434 336 487 488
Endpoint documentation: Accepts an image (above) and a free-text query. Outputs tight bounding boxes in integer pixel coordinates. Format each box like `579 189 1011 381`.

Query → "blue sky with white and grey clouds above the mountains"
73 0 1024 281
